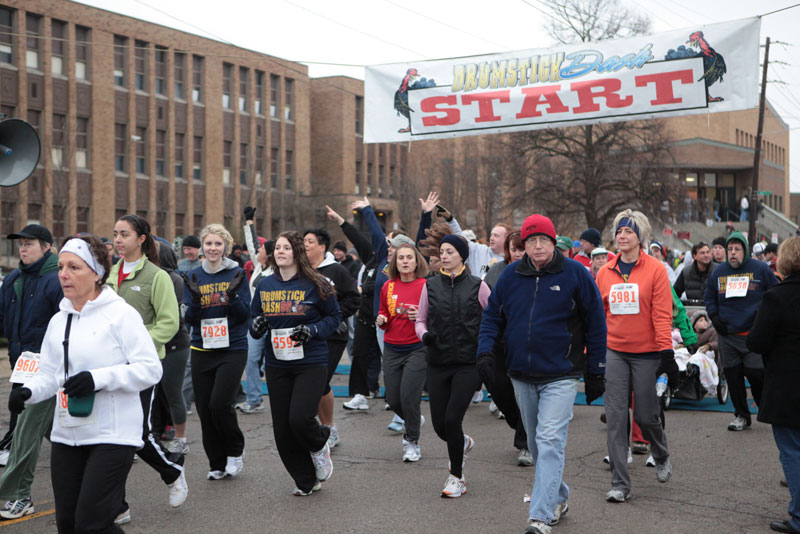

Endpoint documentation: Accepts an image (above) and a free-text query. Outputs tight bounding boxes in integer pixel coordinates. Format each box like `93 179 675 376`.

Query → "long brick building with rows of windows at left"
0 0 310 255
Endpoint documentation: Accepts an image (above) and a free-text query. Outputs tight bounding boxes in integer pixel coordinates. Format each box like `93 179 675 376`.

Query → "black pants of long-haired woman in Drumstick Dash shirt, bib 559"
265 365 331 492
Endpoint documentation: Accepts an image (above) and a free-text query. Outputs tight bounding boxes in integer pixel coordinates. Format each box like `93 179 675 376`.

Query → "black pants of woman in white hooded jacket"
50 443 136 534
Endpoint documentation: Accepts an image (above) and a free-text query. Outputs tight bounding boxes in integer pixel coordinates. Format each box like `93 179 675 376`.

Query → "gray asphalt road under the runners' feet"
0 352 789 534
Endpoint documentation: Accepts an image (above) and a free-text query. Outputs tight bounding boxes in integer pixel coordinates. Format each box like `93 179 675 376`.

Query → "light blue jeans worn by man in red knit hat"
511 378 578 523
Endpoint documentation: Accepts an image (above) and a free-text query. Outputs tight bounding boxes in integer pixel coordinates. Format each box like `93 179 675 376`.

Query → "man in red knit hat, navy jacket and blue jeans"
477 214 606 534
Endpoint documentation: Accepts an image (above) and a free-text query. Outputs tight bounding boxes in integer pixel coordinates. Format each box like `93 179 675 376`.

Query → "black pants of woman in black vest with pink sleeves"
428 364 481 478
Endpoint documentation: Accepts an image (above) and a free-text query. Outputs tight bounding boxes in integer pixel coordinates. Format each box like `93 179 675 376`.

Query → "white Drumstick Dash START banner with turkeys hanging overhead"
364 18 761 143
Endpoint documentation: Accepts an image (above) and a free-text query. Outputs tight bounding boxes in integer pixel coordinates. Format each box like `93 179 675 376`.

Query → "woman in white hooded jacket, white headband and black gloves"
8 236 161 533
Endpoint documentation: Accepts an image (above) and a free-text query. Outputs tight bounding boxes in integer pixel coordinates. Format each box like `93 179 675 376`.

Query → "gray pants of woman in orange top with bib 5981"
605 349 669 493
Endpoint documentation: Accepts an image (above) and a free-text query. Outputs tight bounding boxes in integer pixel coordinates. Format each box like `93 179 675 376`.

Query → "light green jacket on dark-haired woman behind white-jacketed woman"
106 257 180 360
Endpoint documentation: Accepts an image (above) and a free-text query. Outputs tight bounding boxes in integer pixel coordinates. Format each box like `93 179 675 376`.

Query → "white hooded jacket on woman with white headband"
24 286 161 447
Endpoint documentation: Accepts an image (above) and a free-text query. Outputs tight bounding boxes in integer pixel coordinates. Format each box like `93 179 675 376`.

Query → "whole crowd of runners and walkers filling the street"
0 193 800 534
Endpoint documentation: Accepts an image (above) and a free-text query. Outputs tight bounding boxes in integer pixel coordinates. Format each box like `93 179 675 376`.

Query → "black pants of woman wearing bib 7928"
192 349 247 471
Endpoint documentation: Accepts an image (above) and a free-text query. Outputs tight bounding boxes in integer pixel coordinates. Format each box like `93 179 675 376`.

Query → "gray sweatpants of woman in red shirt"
383 345 428 443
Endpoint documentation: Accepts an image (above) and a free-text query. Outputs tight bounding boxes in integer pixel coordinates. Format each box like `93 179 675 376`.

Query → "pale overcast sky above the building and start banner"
75 0 800 192
